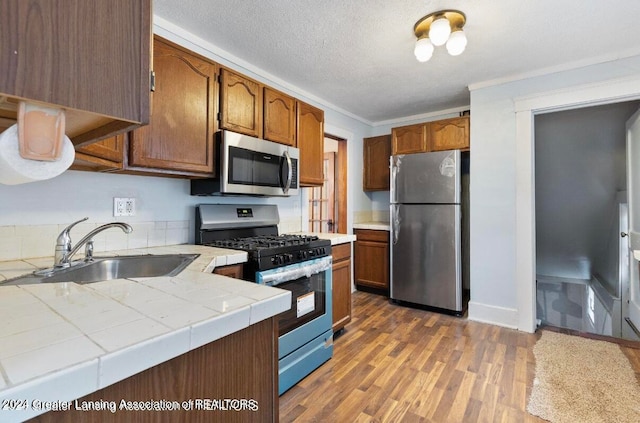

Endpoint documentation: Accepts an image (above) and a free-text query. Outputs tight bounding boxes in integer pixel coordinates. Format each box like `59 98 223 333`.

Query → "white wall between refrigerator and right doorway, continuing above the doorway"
469 56 640 330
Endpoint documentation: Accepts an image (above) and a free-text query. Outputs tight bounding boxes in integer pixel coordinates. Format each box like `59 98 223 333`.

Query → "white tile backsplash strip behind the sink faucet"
0 220 191 261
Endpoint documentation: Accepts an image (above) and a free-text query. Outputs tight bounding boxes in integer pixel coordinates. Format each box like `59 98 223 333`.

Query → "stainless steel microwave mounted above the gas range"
191 130 300 197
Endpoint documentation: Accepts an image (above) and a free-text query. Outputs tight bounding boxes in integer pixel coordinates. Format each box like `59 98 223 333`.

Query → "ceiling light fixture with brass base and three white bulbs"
413 10 467 62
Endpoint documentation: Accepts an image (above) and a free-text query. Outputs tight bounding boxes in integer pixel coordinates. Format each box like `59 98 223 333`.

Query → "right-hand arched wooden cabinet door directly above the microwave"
264 87 296 147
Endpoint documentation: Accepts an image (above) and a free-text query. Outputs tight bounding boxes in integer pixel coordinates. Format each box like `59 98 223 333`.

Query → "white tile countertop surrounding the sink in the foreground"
0 245 291 422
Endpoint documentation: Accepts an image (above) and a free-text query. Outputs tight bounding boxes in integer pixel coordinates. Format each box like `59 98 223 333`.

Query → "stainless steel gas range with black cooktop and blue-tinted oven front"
196 204 333 394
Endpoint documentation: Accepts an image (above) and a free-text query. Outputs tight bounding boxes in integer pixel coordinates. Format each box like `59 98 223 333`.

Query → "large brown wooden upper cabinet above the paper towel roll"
0 0 151 145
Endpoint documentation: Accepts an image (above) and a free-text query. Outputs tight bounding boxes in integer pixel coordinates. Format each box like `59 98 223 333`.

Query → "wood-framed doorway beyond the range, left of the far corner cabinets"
309 134 347 233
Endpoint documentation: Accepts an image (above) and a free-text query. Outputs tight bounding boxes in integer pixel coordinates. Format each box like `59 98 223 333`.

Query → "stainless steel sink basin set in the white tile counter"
2 254 199 285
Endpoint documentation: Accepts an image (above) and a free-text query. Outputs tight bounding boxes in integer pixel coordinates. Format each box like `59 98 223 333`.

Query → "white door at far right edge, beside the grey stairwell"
626 110 640 337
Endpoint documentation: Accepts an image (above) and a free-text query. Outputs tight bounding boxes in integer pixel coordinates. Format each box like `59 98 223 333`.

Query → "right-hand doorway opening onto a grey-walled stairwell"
534 101 640 337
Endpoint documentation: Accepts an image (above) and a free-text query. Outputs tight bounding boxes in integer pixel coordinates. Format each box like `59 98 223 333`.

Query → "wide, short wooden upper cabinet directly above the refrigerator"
391 116 469 154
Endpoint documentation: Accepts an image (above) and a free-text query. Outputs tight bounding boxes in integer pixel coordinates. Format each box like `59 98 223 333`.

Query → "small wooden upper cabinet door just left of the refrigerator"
362 135 391 191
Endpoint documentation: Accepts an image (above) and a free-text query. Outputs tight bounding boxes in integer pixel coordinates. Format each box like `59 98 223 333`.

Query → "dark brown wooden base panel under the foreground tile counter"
32 317 278 423
